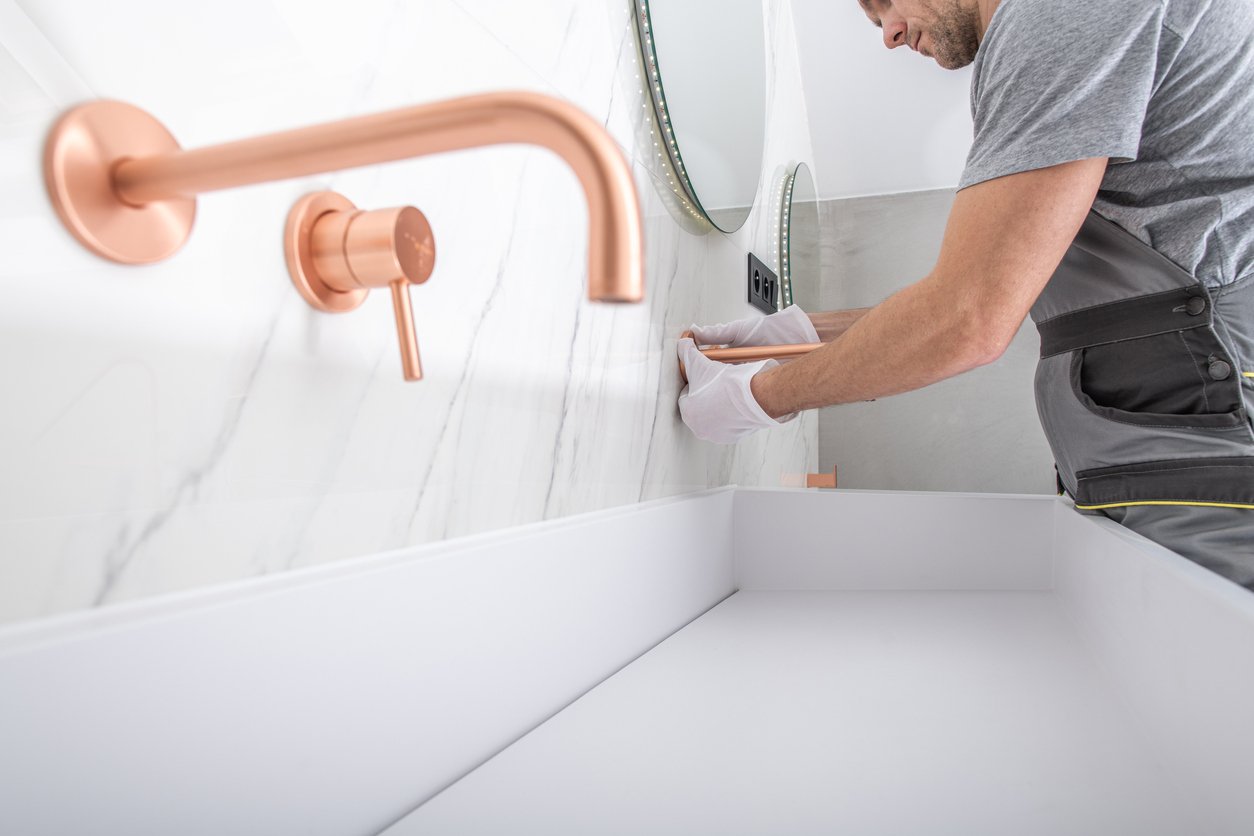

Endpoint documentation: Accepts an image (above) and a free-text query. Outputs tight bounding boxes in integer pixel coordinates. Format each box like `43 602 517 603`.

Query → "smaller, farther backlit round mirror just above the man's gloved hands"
775 163 823 312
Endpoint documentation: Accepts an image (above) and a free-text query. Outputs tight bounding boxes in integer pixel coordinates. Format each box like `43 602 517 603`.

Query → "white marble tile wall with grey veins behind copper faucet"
0 0 818 622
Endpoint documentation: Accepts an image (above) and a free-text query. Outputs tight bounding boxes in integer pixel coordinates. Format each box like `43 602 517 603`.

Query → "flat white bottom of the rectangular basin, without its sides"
387 592 1199 836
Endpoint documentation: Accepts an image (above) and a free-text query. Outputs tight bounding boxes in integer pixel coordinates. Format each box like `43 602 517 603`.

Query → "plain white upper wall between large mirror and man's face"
793 0 971 198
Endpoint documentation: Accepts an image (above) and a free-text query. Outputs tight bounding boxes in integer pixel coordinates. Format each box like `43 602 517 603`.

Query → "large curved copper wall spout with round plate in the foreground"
45 93 645 302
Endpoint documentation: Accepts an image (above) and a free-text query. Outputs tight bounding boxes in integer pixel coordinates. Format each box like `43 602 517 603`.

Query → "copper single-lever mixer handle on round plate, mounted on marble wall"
283 192 435 381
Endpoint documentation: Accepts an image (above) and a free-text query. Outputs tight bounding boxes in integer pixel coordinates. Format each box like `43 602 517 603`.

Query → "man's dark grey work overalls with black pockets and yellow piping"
1032 212 1254 589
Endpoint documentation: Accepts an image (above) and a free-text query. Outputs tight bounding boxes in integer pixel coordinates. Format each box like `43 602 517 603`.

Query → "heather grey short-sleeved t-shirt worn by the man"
959 0 1254 287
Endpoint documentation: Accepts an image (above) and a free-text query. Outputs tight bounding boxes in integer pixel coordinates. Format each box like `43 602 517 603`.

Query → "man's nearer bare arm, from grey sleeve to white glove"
752 158 1106 417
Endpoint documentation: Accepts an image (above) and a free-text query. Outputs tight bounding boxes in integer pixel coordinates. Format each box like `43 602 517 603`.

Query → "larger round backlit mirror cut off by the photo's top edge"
635 0 766 232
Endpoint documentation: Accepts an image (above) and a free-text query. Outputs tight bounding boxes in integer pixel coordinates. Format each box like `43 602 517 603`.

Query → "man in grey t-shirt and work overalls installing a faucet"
680 0 1254 589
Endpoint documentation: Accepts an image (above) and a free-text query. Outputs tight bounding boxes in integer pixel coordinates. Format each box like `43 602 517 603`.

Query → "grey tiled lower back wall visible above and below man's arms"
819 189 1055 494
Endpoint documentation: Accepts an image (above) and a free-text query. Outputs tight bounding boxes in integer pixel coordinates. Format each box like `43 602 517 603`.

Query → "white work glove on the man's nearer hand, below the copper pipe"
678 338 796 444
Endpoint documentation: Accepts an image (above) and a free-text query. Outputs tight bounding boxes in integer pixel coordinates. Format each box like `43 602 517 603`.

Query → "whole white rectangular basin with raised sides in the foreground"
0 489 1254 836
